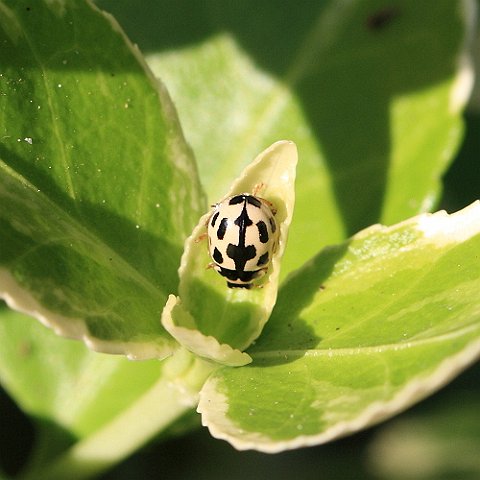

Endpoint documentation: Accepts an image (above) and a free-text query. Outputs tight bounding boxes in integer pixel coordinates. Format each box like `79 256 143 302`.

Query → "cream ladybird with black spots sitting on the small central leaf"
207 193 278 288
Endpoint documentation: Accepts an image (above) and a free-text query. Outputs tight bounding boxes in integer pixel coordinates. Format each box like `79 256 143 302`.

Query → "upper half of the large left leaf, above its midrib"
0 1 203 295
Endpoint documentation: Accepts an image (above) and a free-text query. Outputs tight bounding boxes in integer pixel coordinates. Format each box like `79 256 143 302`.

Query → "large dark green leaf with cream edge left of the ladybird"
0 0 206 358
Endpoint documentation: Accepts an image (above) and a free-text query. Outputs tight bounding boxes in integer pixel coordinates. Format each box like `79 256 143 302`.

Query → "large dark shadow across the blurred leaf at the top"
97 0 460 235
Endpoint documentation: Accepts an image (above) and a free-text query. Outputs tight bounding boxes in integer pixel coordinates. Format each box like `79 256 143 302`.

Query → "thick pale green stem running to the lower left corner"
20 350 216 480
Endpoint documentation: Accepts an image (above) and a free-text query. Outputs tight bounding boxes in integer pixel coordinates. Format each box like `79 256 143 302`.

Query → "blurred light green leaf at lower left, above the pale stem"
0 310 156 437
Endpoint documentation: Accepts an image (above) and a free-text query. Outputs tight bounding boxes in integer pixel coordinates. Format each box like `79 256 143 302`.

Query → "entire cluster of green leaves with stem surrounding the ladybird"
0 0 480 478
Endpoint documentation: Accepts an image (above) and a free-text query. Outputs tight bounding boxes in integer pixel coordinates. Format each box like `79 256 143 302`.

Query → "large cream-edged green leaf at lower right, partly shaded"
198 202 480 452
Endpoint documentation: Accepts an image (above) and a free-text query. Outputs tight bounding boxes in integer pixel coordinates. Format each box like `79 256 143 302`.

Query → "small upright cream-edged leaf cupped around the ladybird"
162 141 297 363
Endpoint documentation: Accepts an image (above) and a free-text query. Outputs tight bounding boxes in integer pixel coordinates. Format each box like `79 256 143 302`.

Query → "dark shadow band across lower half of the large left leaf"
0 146 182 342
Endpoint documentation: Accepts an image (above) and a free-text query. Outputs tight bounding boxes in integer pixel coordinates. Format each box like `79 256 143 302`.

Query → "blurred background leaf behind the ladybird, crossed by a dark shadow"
118 0 475 274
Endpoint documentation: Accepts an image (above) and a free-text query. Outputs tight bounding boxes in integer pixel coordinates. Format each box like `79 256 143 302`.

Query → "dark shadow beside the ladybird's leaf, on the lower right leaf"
247 242 348 366
